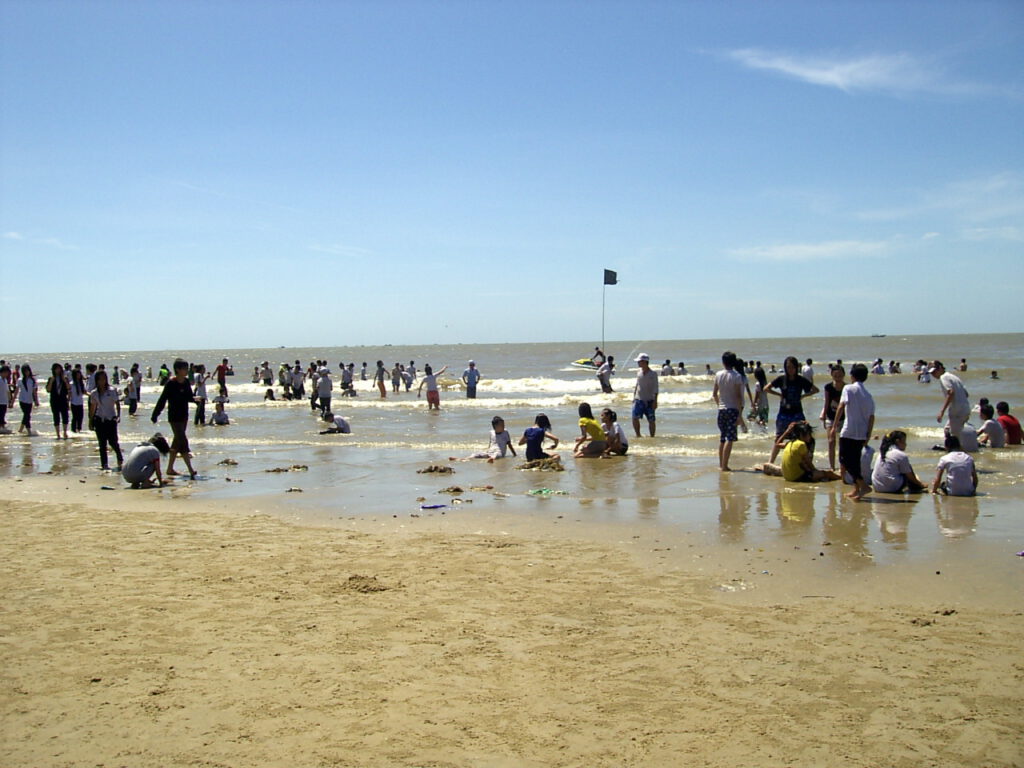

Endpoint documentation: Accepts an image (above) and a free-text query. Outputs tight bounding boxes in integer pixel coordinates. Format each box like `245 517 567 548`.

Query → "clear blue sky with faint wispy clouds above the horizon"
0 0 1024 352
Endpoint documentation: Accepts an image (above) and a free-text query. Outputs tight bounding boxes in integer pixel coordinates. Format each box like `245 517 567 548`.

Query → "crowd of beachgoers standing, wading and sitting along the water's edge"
0 349 1021 501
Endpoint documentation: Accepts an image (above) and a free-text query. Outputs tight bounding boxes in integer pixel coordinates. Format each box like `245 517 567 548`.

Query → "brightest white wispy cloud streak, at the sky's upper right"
726 48 1021 96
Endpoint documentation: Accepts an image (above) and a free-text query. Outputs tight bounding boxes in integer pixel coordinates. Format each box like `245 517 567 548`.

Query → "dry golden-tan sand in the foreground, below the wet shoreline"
0 480 1024 768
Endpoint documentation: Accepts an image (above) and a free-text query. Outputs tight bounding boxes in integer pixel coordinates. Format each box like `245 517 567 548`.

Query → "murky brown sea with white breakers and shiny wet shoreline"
0 334 1024 573
